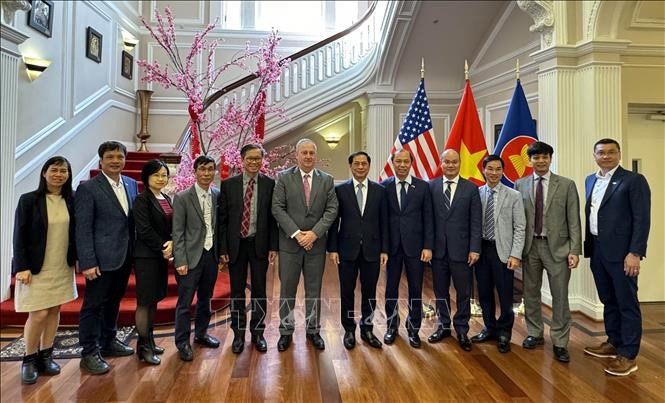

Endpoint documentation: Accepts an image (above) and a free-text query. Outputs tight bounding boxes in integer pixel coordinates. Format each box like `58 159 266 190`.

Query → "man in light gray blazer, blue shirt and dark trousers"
471 155 526 353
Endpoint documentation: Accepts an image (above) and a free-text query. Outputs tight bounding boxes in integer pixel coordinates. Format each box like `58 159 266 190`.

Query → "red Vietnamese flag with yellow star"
445 79 487 186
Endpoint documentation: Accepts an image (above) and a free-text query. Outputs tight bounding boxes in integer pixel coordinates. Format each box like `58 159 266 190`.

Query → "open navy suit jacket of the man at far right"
584 166 651 262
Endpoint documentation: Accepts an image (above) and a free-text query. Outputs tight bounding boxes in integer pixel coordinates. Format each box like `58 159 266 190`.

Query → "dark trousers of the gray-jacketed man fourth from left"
175 250 217 348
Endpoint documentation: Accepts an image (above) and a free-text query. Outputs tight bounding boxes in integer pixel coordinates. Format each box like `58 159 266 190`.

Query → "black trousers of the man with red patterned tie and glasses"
229 237 268 334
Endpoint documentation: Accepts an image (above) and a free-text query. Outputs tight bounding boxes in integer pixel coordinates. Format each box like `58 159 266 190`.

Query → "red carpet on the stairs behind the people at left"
0 152 231 327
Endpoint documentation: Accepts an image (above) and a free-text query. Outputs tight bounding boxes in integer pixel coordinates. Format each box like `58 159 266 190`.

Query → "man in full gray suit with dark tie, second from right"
515 141 582 362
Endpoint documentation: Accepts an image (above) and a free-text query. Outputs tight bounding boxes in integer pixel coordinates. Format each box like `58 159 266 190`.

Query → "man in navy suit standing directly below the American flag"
382 149 434 348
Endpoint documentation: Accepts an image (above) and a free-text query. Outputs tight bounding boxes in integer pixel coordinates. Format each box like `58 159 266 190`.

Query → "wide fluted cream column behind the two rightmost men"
532 44 622 319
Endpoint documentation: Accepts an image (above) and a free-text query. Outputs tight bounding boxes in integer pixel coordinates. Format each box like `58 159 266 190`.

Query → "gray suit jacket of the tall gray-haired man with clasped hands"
272 167 337 253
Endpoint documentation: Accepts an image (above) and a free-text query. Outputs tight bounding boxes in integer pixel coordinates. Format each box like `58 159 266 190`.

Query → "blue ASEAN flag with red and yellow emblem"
494 79 538 187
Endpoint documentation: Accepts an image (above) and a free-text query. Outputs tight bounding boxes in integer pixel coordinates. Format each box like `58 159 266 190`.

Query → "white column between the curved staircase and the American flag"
363 94 396 180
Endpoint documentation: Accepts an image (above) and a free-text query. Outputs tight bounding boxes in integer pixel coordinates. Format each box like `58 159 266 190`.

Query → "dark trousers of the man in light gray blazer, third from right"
475 240 515 339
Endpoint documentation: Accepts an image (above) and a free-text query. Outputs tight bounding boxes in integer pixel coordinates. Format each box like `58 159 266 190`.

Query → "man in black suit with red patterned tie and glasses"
217 144 277 354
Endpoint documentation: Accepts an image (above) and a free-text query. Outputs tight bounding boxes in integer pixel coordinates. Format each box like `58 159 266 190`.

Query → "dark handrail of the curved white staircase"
175 0 378 154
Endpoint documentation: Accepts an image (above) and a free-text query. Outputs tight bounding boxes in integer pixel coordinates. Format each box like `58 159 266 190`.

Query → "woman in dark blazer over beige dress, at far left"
12 157 78 384
